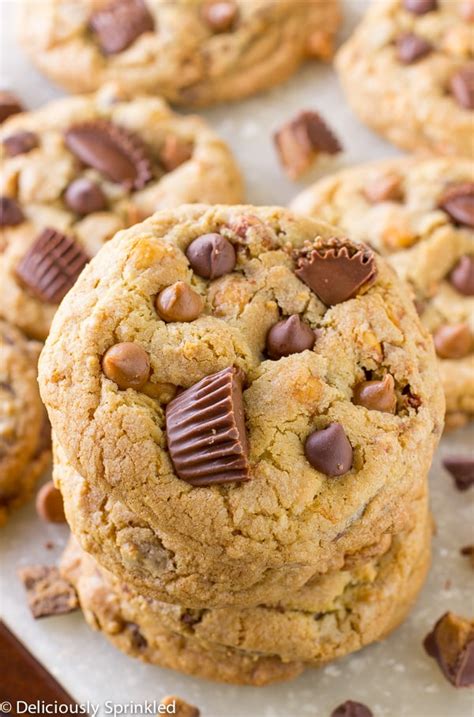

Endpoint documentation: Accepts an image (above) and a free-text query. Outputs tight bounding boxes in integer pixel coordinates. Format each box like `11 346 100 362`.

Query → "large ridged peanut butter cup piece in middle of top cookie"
166 367 250 486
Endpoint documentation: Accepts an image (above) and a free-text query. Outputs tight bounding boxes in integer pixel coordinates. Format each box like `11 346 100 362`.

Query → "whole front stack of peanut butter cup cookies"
40 205 444 684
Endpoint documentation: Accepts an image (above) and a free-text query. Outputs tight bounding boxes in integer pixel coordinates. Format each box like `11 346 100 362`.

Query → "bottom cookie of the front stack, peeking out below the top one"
62 500 431 685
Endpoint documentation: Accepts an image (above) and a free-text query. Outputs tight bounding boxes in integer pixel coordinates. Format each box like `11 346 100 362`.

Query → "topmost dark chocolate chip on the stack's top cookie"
186 234 237 279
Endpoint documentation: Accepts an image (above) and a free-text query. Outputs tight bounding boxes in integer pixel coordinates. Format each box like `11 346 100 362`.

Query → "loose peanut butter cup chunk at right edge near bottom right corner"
423 612 474 687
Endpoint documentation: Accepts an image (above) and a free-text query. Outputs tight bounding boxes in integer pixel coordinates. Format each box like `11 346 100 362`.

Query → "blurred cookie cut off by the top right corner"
336 0 474 157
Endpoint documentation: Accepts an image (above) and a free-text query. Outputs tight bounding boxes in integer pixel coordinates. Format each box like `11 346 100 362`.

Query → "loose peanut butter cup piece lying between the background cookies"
273 110 342 179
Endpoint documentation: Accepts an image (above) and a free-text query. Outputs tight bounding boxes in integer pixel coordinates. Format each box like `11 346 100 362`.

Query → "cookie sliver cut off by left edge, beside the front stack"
0 320 51 525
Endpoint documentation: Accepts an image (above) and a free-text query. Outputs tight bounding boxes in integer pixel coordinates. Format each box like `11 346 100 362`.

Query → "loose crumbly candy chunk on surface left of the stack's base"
19 565 79 618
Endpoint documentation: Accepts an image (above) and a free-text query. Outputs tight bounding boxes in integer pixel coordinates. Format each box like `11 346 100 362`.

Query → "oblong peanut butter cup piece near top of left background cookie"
65 120 153 190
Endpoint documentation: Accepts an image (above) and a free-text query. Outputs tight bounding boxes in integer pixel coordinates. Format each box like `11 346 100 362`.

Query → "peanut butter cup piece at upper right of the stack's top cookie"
295 238 377 306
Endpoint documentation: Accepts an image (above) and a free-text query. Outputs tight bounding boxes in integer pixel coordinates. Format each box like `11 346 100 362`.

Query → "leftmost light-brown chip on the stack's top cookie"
102 341 150 390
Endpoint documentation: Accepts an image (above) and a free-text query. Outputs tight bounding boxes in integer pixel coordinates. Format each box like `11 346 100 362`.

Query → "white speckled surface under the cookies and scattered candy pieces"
0 0 474 717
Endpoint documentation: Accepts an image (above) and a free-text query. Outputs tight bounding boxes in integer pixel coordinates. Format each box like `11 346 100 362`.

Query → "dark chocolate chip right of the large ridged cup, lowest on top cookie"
304 423 352 477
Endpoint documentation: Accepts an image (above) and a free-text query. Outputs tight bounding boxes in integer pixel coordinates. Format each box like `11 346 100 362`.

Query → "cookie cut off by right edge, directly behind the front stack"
291 157 474 426
